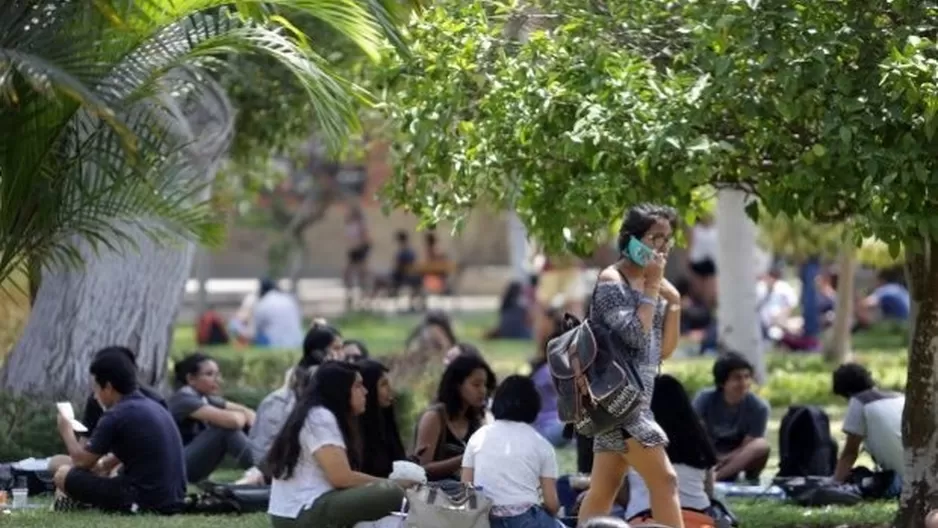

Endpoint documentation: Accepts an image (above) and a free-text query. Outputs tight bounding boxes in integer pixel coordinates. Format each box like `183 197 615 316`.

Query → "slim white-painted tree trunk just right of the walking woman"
716 189 766 382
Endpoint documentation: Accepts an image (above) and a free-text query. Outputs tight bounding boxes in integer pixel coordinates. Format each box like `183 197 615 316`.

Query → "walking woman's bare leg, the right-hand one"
625 438 684 528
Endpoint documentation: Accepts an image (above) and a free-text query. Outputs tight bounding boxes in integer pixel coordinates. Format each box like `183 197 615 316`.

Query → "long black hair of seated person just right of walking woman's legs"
651 374 717 470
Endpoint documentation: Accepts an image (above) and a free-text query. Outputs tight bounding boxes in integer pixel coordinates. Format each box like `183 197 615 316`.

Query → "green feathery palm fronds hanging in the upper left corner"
0 0 390 286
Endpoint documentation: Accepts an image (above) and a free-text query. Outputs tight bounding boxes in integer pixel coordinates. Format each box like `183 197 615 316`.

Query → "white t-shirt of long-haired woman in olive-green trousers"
267 407 345 519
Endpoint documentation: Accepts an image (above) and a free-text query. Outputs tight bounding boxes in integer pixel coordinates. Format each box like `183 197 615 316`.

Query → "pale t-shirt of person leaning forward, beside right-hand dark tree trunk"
843 389 905 472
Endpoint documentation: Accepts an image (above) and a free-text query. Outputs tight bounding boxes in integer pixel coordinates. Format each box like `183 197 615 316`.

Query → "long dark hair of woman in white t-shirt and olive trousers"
266 361 361 480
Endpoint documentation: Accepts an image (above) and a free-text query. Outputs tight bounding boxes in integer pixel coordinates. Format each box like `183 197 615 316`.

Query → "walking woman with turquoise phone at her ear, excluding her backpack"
579 204 684 528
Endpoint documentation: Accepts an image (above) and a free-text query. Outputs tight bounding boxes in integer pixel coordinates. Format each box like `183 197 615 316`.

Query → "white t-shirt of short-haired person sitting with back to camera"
462 420 557 506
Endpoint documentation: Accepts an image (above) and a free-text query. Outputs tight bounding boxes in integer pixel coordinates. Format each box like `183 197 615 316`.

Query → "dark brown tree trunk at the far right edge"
895 241 938 528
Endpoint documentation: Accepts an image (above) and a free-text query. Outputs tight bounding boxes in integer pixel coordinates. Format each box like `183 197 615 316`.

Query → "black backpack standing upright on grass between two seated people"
778 405 837 477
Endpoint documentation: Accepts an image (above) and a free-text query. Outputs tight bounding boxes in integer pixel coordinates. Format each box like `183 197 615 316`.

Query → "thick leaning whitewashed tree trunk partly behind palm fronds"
0 71 234 400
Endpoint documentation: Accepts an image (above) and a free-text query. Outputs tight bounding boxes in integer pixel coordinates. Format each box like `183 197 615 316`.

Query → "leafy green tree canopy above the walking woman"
380 0 938 256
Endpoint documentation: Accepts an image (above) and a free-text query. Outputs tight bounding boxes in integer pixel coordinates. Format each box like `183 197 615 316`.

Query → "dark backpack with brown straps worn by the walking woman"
547 290 644 436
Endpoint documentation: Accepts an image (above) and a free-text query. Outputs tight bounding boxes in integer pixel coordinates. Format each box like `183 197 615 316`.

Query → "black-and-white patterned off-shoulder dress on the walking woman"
590 282 668 453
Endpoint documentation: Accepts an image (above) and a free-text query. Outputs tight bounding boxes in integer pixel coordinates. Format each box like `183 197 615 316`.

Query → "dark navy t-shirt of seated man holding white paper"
85 391 186 510
